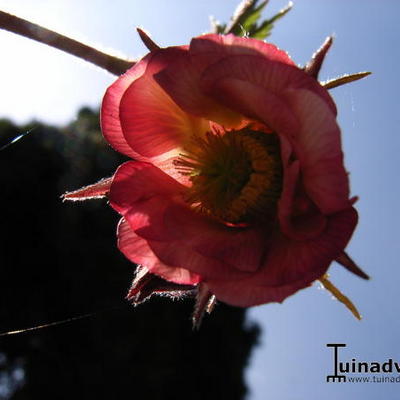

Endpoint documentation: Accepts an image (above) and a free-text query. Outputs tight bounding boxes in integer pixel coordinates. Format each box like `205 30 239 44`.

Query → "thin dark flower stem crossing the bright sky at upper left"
0 11 135 75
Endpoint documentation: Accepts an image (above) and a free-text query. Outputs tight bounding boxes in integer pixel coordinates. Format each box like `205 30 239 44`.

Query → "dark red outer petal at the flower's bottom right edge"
205 208 357 307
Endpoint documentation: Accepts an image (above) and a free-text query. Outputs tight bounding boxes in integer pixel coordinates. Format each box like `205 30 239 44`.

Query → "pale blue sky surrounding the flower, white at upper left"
0 0 400 400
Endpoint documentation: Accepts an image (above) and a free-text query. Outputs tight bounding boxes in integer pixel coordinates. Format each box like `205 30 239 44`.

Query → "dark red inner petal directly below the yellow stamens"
124 196 265 279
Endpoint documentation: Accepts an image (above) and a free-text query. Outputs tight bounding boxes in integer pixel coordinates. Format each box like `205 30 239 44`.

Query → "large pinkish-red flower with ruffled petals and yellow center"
67 35 363 322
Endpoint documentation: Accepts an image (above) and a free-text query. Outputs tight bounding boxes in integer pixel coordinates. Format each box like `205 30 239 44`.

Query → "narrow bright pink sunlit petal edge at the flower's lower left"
117 218 200 285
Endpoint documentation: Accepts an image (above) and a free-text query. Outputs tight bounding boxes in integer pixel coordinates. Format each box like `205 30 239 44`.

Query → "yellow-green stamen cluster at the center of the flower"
175 129 282 223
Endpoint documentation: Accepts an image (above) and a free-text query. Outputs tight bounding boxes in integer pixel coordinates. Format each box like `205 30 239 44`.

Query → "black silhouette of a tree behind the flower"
0 108 259 400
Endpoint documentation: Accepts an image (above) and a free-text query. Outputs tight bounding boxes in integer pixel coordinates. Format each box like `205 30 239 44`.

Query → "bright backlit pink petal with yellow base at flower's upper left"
101 47 208 161
